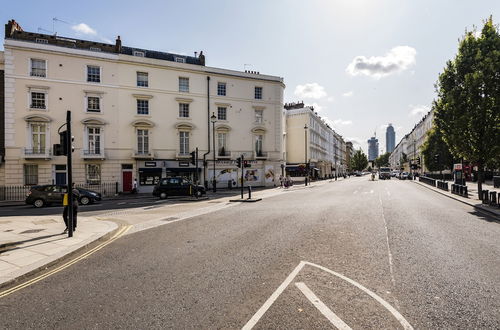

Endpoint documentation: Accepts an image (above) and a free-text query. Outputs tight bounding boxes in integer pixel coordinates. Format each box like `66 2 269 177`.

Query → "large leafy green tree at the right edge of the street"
433 17 500 191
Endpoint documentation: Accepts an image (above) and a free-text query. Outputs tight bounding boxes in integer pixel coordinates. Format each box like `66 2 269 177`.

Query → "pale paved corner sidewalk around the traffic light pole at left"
0 216 118 287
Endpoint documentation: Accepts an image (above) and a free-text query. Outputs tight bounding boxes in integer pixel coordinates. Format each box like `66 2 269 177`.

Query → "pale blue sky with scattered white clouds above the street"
0 0 500 151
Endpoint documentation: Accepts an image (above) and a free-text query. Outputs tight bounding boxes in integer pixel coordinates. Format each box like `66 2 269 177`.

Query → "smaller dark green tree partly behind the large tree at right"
422 128 453 172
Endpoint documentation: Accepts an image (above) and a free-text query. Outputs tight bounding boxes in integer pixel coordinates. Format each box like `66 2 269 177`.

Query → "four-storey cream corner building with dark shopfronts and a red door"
0 20 285 192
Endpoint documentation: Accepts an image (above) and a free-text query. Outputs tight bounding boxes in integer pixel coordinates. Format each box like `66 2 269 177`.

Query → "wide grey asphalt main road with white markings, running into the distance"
0 177 500 329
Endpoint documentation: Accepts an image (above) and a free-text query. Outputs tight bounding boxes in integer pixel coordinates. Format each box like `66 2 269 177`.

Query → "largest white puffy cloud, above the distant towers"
346 46 417 79
